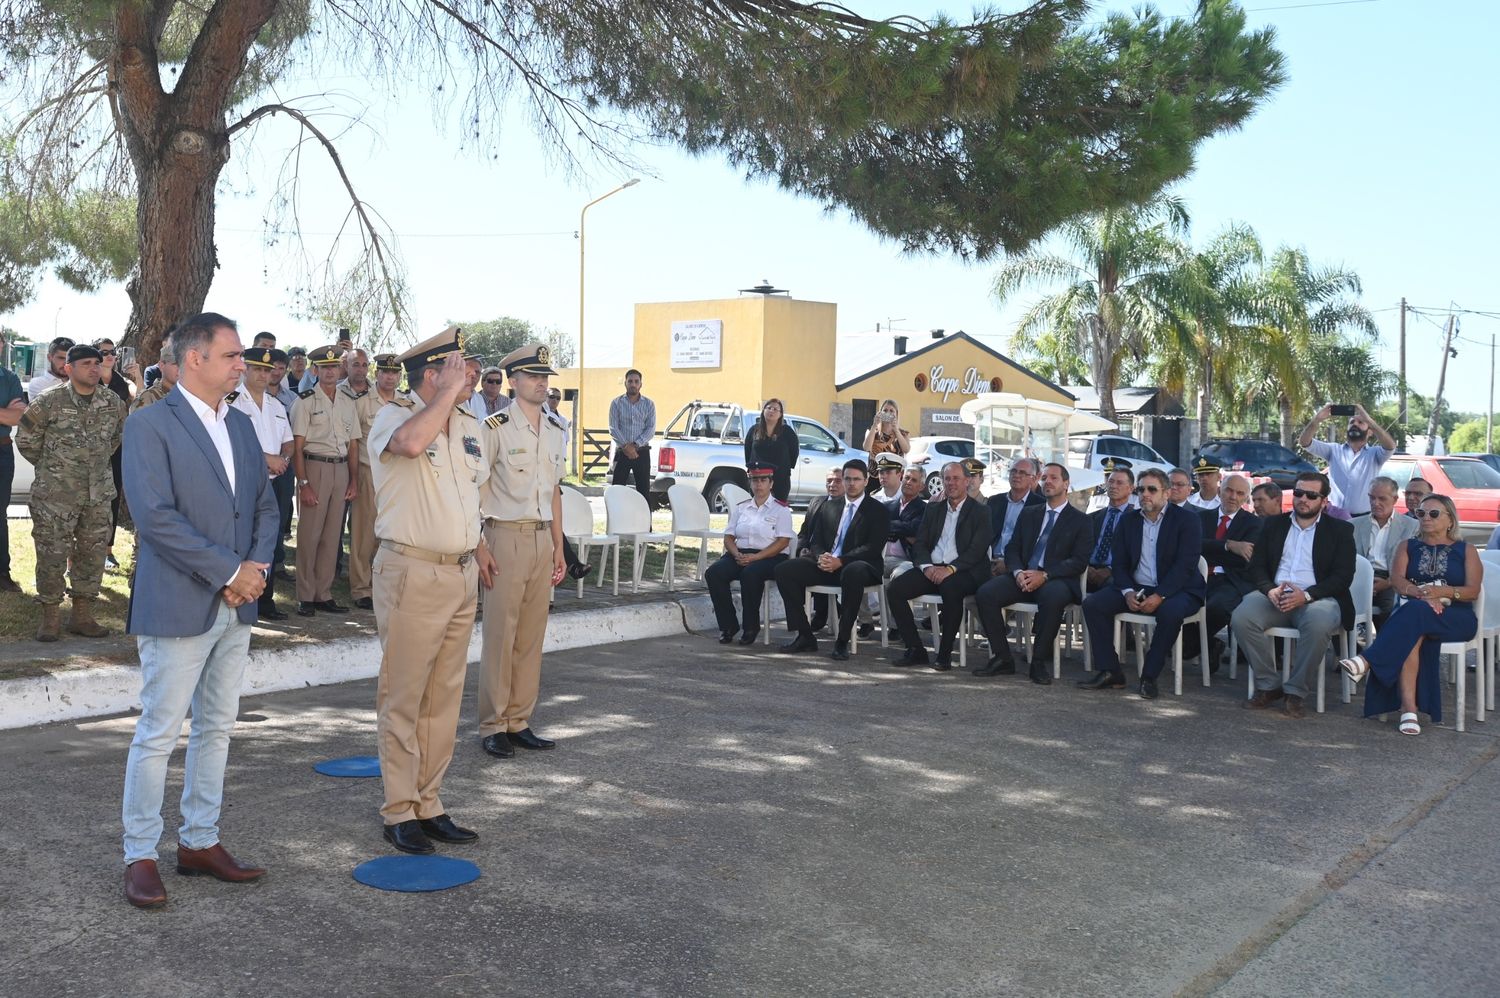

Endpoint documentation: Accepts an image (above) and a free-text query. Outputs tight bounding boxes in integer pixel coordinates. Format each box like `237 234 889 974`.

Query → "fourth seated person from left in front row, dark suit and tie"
974 464 1094 686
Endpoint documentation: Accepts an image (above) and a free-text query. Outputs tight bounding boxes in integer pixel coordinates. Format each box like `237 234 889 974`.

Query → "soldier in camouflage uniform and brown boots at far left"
15 344 126 641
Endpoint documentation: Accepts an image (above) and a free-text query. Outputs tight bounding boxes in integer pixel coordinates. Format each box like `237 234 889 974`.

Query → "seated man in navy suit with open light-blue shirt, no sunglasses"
1079 468 1205 699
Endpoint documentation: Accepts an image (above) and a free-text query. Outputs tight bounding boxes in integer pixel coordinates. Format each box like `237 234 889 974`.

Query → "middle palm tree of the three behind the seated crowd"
1154 225 1262 441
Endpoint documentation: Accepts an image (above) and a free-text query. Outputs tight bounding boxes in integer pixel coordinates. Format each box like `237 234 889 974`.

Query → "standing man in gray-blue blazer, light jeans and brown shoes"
122 312 281 908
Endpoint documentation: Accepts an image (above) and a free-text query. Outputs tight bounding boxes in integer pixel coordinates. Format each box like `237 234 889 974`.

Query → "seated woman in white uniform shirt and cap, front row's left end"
704 461 797 645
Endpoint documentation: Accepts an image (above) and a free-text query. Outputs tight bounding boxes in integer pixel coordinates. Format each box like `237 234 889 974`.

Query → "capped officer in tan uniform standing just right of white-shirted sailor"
291 347 360 617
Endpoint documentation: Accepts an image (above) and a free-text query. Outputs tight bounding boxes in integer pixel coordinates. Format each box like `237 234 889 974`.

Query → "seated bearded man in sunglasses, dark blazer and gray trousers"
1230 473 1355 717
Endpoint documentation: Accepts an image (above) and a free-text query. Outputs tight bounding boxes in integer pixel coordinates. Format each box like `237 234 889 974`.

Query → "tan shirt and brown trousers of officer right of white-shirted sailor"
291 387 360 603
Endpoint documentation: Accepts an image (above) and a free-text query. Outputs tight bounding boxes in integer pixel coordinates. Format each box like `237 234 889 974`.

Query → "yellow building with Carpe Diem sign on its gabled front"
554 294 1074 462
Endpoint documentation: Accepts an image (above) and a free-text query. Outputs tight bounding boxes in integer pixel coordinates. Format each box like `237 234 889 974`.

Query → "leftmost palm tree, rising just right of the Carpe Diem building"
995 195 1188 422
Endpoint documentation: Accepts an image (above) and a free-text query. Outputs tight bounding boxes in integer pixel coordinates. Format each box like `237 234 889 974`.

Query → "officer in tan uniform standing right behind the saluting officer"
479 344 567 759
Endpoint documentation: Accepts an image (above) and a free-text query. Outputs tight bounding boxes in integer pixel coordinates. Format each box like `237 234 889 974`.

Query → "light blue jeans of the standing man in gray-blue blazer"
122 602 251 864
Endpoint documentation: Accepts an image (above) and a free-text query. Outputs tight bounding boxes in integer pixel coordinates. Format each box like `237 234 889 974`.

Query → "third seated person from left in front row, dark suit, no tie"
885 461 990 672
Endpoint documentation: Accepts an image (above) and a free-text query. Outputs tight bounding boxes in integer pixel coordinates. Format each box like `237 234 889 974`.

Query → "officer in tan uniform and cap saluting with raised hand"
368 327 495 852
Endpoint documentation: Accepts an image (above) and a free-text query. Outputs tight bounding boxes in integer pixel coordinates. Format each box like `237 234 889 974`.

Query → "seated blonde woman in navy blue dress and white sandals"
1340 495 1484 735
